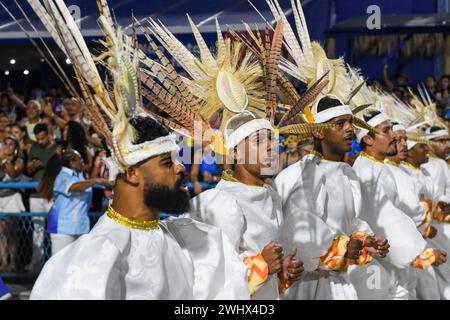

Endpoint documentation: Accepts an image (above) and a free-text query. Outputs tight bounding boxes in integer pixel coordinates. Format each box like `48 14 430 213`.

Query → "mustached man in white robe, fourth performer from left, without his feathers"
353 110 434 299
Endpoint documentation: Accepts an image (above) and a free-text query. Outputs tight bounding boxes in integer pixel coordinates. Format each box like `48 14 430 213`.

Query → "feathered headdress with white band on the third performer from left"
260 0 375 142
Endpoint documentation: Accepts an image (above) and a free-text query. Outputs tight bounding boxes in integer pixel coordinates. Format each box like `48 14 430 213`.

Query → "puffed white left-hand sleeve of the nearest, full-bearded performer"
30 235 124 300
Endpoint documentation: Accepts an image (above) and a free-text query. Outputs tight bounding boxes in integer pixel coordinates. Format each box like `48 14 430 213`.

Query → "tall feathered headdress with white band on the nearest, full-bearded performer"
18 0 185 180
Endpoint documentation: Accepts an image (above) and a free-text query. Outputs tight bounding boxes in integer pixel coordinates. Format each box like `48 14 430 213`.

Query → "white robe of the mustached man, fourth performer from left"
353 156 426 299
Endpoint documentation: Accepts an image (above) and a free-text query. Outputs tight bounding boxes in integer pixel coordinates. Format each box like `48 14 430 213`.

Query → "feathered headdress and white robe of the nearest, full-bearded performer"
26 0 251 299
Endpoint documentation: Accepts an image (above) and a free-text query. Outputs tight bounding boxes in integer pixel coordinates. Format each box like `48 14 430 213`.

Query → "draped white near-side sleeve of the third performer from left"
274 157 338 271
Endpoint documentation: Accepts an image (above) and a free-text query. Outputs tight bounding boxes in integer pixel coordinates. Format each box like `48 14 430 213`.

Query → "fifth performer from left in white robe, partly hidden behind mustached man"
385 123 447 300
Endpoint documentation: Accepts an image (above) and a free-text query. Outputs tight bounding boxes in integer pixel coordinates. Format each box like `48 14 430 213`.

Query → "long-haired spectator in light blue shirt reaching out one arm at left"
38 150 107 255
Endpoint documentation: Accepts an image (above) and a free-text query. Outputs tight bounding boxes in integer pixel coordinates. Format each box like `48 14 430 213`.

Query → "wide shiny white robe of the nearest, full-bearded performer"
31 215 249 300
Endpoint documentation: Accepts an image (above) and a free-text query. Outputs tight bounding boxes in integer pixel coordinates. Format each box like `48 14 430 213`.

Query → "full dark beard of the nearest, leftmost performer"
144 174 190 214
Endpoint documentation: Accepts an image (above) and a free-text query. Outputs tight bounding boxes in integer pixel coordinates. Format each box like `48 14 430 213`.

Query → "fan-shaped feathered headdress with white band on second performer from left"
142 16 332 153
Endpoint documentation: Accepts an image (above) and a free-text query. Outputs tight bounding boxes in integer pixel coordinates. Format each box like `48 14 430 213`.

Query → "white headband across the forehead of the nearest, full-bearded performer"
106 134 180 181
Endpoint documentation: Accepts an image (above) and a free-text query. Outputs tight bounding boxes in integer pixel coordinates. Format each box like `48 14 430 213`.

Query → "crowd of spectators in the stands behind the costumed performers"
0 66 450 273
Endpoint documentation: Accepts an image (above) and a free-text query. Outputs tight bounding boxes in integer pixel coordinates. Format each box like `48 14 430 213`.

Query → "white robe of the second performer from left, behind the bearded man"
190 179 284 299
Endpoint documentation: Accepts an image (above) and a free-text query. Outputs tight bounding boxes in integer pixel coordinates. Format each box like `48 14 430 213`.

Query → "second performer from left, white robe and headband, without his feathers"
187 111 303 300
